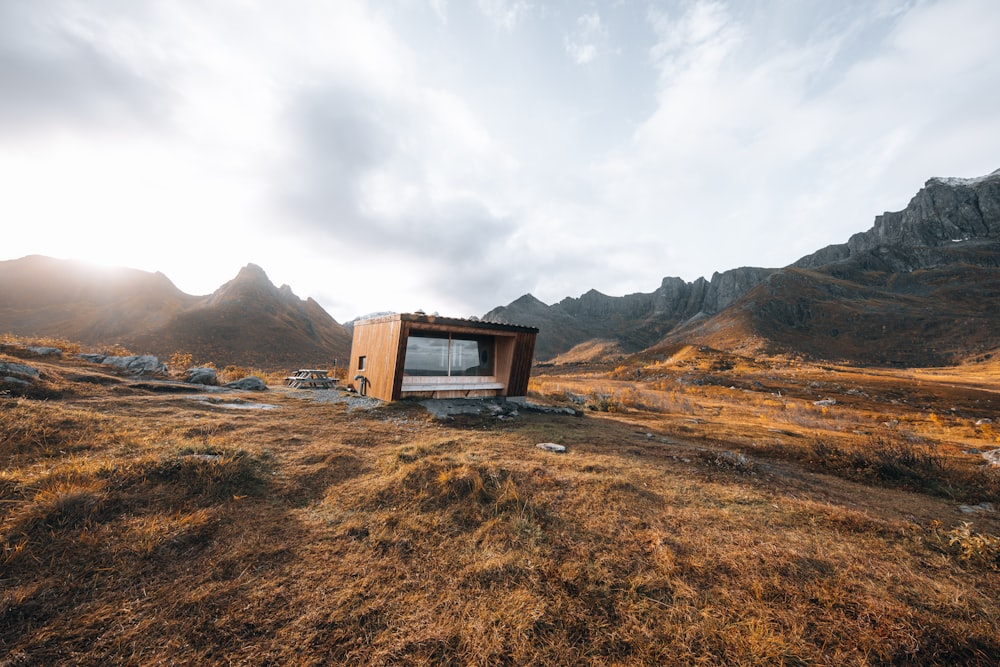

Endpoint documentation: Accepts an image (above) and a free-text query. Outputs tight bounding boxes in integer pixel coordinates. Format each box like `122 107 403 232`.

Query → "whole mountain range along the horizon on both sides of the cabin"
0 170 1000 368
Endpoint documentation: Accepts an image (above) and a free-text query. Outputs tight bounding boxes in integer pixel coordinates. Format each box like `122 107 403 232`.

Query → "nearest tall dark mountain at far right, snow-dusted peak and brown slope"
663 170 1000 366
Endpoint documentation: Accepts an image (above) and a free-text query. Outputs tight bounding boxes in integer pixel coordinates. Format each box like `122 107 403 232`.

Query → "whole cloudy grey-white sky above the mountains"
0 0 1000 321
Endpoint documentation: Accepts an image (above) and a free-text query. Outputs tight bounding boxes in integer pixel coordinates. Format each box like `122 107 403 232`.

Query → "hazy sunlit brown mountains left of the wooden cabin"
0 256 351 368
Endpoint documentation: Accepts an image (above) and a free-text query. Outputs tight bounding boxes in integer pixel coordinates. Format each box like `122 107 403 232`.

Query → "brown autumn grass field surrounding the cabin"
0 346 1000 667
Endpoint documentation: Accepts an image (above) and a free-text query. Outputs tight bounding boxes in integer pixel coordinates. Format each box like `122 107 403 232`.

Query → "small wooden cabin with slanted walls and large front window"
347 313 538 401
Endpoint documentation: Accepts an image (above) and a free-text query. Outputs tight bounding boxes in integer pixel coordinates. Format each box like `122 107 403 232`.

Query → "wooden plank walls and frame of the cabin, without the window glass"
348 313 538 401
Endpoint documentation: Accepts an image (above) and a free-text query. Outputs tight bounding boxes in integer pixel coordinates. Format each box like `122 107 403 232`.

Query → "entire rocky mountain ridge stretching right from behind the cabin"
484 170 1000 365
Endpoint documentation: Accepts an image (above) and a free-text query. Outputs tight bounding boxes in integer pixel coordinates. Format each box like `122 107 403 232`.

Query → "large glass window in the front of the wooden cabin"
403 334 493 376
